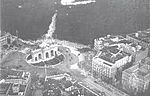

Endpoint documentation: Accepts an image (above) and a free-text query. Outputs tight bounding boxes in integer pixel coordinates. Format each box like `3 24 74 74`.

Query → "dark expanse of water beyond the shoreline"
1 0 150 44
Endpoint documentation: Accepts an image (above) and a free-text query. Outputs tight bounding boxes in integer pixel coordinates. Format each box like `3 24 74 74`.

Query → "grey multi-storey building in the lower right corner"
122 63 150 93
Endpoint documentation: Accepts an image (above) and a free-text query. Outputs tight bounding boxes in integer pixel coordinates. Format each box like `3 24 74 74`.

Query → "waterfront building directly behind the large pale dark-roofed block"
94 35 148 62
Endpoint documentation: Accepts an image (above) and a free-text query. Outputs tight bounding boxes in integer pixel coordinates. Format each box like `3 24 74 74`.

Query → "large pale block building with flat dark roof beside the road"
92 46 131 78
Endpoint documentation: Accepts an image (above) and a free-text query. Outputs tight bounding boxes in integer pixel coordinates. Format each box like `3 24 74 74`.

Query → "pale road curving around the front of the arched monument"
2 46 108 96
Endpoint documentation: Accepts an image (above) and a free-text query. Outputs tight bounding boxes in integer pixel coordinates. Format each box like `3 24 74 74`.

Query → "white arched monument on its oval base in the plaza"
26 46 65 68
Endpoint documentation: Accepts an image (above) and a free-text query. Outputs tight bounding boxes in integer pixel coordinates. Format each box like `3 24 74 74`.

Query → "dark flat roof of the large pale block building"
98 46 130 63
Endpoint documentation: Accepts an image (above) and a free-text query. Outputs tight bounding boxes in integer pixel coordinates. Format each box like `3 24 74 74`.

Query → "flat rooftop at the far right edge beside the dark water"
128 30 150 43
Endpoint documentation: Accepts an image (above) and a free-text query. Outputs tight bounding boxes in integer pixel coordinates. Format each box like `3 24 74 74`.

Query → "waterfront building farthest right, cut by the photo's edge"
126 30 150 48
